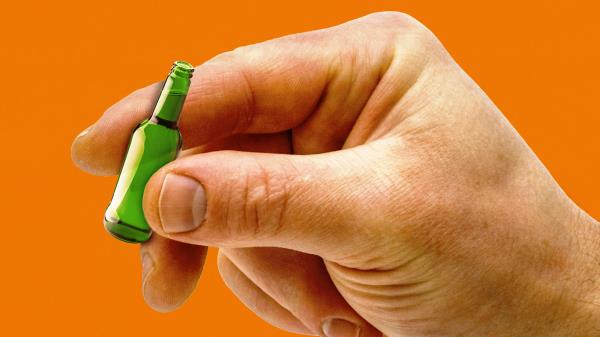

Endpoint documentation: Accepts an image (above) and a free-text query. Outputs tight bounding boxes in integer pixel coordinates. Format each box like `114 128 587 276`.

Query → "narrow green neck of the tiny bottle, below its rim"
152 70 190 125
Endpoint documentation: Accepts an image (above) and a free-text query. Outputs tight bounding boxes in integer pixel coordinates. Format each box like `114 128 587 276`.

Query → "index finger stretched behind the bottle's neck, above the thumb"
72 14 414 174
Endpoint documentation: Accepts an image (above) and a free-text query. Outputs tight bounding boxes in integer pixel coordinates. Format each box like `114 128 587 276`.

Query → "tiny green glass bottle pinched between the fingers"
104 61 194 243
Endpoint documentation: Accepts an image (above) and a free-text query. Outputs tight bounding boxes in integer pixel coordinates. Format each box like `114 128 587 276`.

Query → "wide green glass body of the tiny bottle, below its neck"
104 120 181 243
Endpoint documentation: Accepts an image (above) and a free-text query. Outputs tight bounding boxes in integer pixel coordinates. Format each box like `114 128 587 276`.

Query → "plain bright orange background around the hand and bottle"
0 0 600 337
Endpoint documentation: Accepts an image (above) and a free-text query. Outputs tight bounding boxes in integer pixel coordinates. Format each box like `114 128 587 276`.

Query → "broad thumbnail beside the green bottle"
158 173 206 233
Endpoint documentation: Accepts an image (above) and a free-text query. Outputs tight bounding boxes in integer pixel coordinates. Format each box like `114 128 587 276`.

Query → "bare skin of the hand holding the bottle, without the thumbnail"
72 12 600 337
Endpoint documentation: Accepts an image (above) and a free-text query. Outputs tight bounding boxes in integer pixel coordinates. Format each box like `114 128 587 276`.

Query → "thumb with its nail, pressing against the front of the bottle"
144 142 392 261
